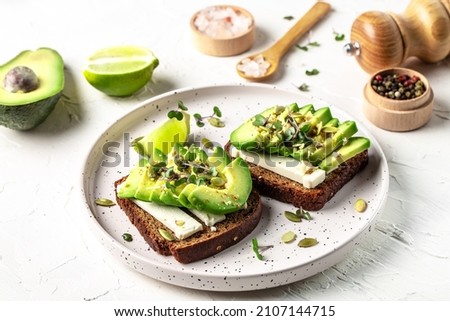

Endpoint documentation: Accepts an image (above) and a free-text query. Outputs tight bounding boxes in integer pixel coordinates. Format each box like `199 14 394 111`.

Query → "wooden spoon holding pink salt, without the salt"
236 1 331 81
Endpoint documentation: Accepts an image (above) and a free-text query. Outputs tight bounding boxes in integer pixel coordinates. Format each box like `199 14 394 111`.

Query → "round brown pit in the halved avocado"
3 66 39 93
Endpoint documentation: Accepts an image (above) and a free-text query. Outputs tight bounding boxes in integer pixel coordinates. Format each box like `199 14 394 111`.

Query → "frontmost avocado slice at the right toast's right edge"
319 137 370 173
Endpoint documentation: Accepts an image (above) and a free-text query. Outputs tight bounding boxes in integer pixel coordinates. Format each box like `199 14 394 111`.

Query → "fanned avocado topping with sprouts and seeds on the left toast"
118 143 252 215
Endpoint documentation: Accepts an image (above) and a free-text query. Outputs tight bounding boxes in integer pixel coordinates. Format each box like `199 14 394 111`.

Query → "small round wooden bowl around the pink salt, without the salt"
190 5 255 57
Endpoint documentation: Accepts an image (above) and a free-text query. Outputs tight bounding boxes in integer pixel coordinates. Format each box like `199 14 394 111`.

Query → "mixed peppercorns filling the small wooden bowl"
371 74 426 100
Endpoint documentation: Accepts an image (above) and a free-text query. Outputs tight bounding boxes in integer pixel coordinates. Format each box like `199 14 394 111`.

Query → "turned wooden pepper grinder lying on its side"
344 0 450 73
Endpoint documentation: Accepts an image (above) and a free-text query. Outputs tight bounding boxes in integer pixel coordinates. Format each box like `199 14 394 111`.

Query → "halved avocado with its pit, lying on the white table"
0 48 64 130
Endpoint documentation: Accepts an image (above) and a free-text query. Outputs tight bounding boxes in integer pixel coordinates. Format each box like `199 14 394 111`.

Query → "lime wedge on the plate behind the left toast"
135 112 190 161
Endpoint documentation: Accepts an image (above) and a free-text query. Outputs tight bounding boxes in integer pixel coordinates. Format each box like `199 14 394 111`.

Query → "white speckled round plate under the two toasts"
82 84 389 291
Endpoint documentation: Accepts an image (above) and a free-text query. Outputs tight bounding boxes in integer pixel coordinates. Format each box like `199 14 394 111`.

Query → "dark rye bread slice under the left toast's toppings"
114 177 262 263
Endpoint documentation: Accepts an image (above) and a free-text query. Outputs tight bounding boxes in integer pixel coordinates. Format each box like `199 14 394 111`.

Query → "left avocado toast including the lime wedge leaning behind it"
115 114 262 263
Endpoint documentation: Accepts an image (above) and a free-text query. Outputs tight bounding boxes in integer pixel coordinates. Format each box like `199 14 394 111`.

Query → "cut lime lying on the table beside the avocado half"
83 46 159 96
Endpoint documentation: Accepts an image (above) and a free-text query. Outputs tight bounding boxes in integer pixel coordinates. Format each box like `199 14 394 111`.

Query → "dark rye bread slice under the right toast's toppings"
225 142 369 211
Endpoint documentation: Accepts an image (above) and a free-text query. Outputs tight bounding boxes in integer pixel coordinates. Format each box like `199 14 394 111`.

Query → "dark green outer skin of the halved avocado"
0 92 62 131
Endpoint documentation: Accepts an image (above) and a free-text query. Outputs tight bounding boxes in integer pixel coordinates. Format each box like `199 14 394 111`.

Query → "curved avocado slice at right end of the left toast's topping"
187 157 252 214
